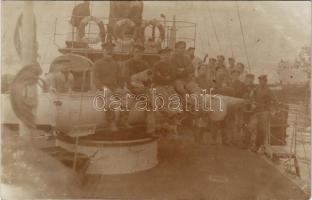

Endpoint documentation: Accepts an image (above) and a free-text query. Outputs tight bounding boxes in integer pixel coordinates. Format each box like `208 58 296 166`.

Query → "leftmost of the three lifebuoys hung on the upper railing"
78 16 106 44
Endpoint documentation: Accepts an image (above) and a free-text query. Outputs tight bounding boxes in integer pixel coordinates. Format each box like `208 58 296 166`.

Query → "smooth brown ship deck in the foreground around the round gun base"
4 128 307 200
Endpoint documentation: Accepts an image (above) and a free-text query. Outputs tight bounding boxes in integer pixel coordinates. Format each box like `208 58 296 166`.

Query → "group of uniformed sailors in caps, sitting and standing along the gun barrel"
93 41 275 151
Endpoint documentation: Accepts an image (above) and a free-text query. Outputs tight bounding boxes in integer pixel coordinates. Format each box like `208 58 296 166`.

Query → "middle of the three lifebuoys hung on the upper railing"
113 19 135 40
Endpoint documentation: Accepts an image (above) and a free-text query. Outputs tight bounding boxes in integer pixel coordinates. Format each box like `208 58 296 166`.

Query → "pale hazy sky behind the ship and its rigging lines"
1 1 311 80
